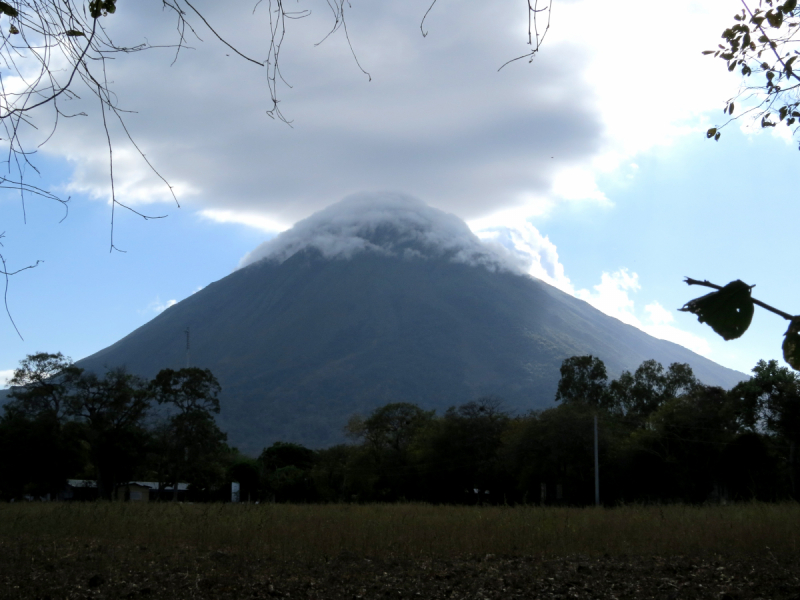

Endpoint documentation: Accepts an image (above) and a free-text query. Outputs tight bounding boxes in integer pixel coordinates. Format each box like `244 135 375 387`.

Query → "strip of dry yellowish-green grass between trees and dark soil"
0 503 800 562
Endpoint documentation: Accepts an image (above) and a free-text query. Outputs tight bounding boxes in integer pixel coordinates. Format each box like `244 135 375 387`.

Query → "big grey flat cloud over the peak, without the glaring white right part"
36 0 603 223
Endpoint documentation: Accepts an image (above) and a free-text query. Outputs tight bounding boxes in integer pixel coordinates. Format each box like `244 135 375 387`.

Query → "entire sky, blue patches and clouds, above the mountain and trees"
0 0 800 384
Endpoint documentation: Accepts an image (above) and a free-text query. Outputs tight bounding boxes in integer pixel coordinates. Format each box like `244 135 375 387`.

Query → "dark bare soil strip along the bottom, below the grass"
0 541 800 600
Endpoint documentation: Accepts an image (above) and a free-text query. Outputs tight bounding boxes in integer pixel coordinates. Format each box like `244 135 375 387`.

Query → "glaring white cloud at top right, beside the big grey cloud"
542 0 741 203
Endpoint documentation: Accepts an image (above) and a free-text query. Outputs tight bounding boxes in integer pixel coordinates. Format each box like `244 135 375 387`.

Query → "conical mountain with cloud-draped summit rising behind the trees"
79 195 744 452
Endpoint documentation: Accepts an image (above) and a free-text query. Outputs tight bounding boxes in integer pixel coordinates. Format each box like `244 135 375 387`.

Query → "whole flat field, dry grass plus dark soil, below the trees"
0 503 800 600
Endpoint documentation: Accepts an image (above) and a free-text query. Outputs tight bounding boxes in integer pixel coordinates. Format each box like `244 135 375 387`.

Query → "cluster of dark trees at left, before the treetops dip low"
0 353 231 500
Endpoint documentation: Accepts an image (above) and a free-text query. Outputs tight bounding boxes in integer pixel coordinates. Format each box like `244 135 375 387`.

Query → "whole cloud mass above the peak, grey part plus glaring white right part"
17 0 752 241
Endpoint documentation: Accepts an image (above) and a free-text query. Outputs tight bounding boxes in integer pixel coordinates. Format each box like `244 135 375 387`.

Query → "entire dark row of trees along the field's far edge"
0 354 800 505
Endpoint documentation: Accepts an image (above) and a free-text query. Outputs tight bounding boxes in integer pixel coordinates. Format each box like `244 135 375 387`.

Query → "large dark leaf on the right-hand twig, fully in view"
680 279 754 340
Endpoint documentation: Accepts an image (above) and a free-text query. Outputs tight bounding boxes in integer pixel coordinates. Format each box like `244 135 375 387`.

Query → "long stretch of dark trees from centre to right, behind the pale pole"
257 356 800 505
